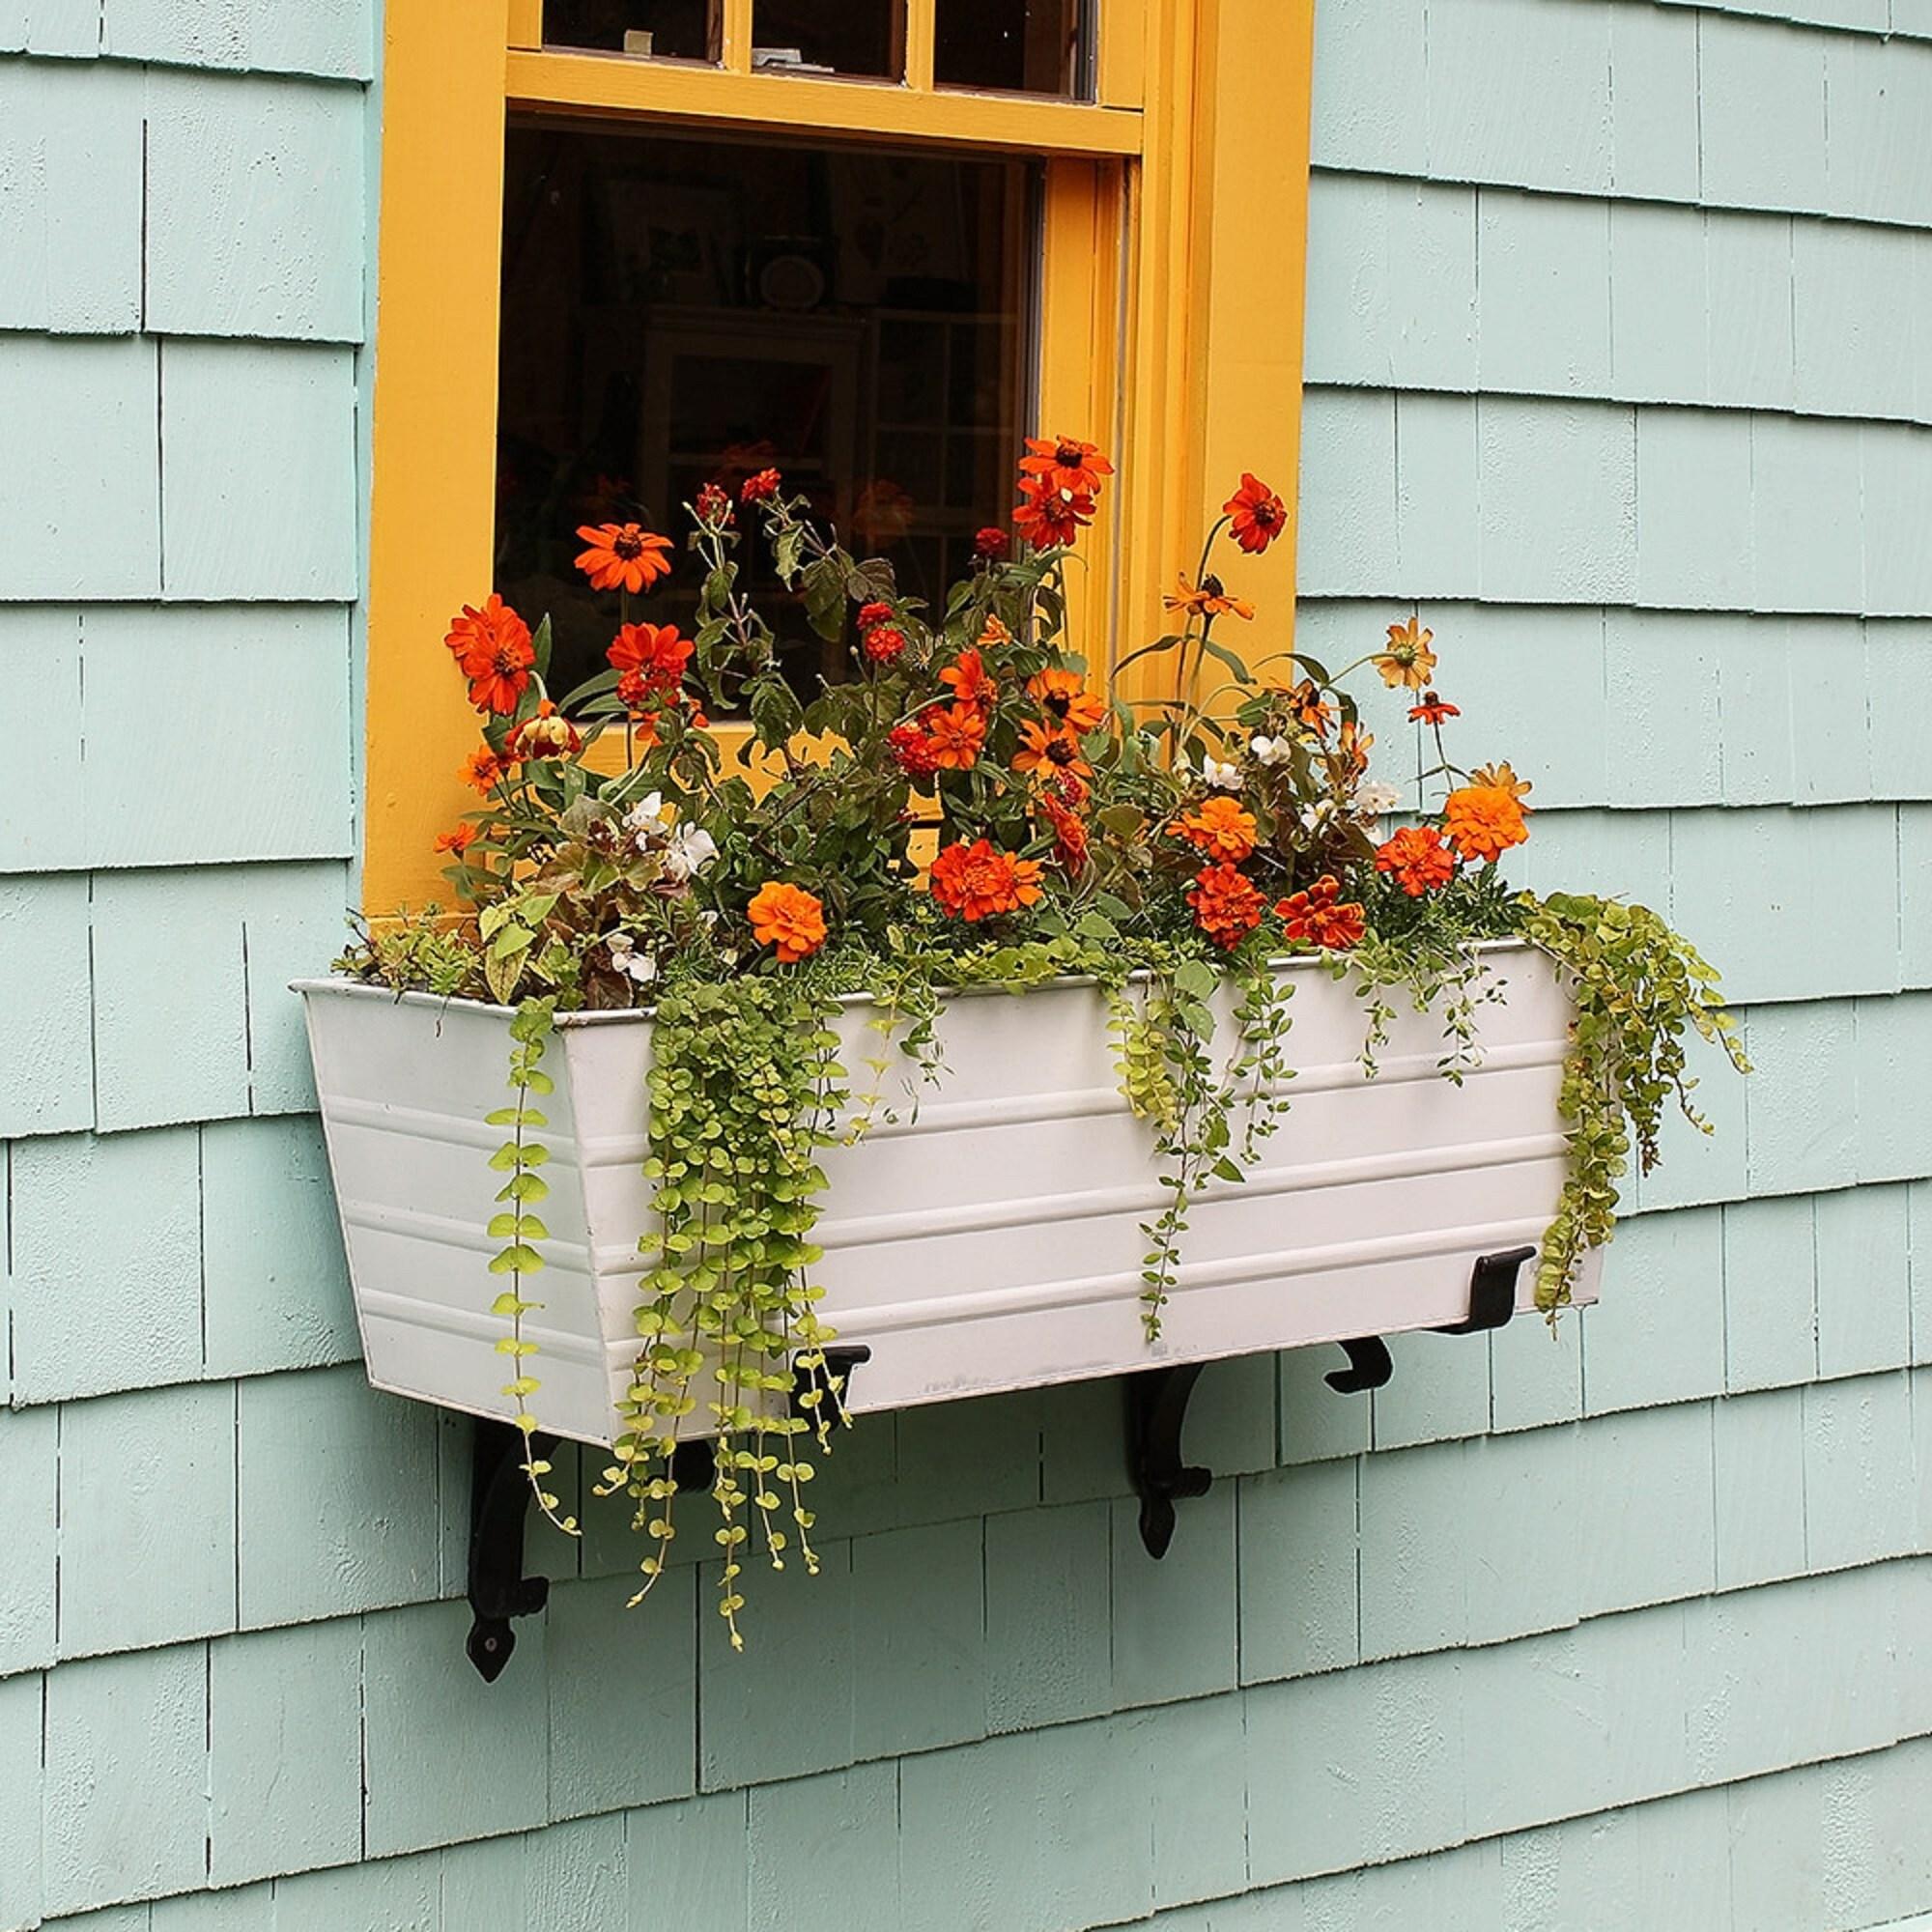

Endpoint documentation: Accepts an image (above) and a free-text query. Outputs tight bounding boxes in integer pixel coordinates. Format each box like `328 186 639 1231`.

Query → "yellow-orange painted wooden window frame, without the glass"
361 0 1314 914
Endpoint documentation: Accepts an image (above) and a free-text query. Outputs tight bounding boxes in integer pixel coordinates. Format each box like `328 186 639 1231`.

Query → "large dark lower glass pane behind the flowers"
497 124 1037 696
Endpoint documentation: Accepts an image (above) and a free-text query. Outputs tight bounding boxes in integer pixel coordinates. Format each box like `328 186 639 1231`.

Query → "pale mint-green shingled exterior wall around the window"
0 0 1932 1932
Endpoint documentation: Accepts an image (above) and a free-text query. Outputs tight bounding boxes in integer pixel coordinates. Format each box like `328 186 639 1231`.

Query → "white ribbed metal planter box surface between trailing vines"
299 947 1598 1441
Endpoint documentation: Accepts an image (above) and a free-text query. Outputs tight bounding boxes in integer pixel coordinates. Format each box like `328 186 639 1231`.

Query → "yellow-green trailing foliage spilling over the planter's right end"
1517 893 1750 1320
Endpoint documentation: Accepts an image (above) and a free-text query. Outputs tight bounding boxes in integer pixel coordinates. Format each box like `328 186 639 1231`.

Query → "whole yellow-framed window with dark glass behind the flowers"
363 0 1314 910
